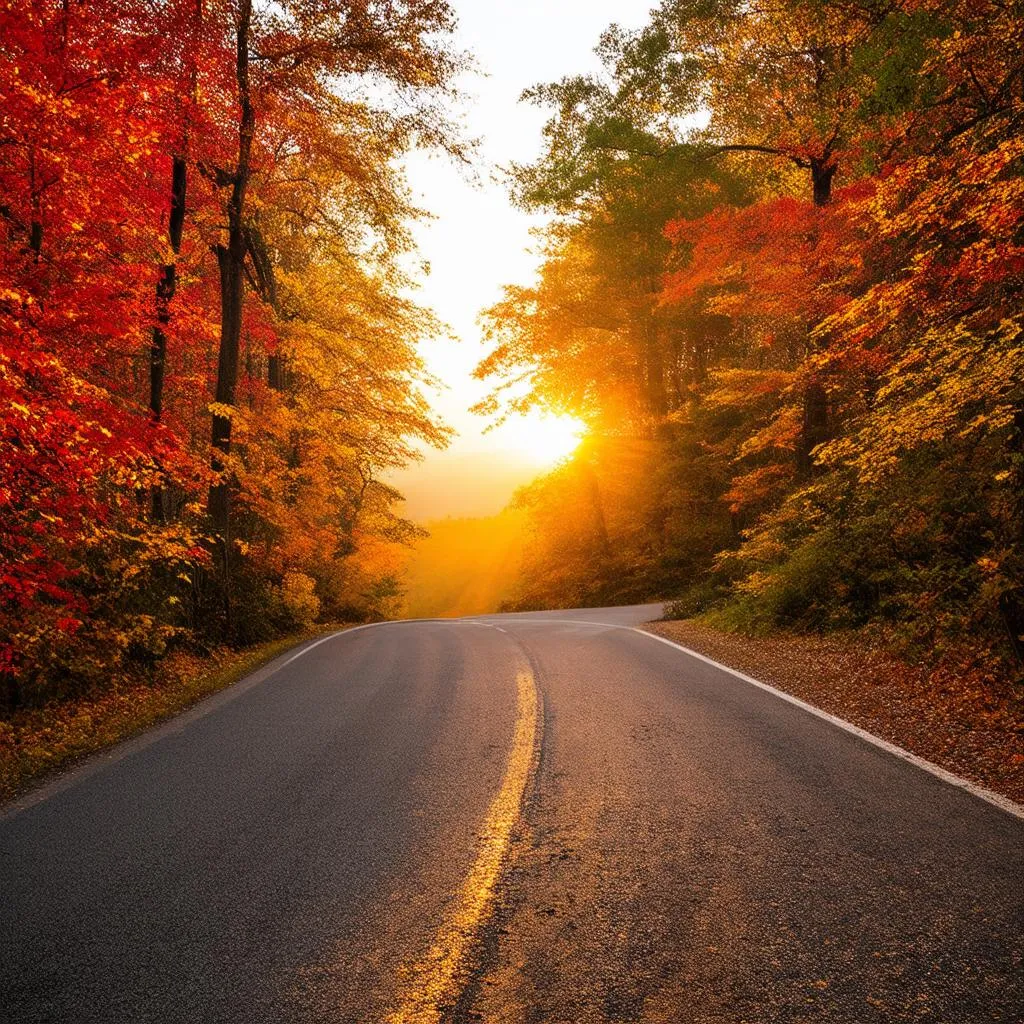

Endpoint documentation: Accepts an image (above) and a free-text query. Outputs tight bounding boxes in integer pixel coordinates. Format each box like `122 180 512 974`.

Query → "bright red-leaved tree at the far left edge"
0 2 199 702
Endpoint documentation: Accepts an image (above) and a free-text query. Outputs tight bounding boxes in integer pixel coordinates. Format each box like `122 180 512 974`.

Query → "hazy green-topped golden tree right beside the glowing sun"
477 24 748 601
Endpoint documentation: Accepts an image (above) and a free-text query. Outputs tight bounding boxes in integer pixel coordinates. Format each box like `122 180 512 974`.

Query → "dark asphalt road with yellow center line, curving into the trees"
0 606 1024 1024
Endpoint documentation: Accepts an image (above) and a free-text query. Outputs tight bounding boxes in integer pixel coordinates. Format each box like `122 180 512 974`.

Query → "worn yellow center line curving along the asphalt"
387 672 541 1024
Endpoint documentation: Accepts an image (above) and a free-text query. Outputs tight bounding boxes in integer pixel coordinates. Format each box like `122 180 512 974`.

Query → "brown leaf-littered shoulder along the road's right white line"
643 620 1024 803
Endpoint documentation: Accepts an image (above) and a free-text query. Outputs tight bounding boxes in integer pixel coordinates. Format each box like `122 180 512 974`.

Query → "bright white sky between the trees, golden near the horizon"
392 0 653 519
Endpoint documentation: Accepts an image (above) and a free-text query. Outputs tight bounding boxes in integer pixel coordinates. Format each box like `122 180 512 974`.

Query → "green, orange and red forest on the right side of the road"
477 0 1024 666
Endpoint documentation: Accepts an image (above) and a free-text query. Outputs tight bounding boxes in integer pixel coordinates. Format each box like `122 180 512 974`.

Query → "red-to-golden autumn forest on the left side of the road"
0 0 464 709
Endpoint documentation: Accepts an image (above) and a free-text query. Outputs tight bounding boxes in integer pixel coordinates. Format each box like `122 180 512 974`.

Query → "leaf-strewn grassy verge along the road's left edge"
0 624 345 804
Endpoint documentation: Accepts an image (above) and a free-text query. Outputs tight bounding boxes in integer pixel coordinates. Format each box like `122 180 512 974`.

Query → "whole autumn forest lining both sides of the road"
0 0 1024 729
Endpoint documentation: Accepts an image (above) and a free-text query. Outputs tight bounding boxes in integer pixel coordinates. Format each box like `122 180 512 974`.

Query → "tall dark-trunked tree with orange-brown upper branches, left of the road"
191 0 457 621
